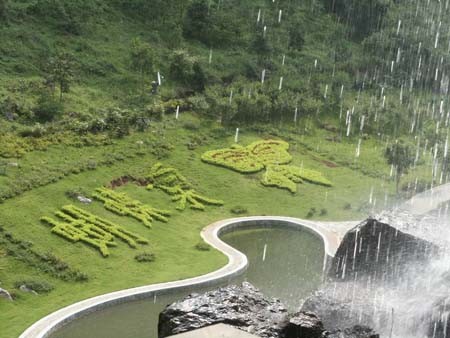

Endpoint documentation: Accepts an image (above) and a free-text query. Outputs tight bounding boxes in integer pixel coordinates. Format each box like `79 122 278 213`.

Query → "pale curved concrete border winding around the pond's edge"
19 216 360 338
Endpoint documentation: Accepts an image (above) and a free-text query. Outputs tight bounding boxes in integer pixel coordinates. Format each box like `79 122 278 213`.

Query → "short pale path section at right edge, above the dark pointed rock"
399 183 450 215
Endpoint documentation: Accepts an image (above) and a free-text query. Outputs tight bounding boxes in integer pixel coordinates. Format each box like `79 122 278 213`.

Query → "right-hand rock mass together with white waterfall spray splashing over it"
302 219 447 338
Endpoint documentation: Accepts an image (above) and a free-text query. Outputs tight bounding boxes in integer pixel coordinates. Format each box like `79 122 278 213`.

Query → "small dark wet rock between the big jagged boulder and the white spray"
283 312 324 338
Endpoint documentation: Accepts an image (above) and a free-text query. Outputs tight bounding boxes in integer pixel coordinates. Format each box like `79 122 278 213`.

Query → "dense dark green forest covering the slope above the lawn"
0 0 450 162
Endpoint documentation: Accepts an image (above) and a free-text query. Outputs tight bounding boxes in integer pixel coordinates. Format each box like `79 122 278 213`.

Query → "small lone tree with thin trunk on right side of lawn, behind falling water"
384 140 414 194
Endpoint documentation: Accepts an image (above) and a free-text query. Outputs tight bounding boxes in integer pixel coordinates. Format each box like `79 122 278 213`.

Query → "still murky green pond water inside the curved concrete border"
51 227 324 338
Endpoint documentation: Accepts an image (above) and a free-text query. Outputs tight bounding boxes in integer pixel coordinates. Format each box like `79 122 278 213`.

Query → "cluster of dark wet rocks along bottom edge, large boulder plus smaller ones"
158 283 378 338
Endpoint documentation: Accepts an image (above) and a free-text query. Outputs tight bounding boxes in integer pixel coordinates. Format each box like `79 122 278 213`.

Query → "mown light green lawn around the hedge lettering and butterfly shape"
0 115 408 338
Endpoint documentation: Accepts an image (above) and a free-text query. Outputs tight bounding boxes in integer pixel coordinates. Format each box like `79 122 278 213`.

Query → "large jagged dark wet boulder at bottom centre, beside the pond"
158 283 288 338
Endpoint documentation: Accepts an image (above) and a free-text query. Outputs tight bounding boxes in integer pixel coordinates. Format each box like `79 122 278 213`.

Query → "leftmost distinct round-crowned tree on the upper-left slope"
45 53 74 102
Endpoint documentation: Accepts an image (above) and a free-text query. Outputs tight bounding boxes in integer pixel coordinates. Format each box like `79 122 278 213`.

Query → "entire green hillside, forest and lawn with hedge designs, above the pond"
0 0 450 338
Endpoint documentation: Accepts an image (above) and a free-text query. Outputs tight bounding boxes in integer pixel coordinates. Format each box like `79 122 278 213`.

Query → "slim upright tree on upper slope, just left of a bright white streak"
130 38 155 97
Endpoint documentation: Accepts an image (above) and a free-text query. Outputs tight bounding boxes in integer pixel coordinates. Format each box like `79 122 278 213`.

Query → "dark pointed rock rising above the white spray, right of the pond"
329 219 439 282
